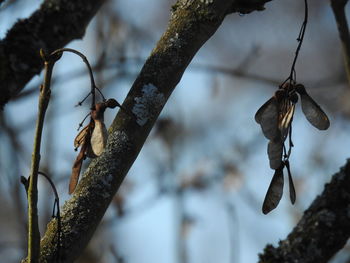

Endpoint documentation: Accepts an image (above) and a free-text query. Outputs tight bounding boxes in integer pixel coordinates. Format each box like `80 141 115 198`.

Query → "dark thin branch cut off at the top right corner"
331 0 350 85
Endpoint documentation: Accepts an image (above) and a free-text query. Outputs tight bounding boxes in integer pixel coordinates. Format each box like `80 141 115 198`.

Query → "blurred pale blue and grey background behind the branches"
0 0 350 263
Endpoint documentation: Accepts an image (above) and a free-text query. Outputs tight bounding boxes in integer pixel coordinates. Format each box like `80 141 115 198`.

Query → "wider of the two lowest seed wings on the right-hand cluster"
262 167 284 215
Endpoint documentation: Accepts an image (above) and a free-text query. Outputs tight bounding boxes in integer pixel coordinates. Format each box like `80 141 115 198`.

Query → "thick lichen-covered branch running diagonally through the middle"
17 0 272 262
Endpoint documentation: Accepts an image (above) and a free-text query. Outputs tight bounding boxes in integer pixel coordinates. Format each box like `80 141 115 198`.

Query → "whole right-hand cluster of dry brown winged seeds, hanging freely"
255 82 330 214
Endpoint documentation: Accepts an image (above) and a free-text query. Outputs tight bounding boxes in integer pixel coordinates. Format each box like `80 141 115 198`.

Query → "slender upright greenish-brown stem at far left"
28 53 55 263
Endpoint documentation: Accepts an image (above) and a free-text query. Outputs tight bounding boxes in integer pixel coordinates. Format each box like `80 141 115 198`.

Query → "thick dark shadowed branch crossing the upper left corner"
0 0 104 108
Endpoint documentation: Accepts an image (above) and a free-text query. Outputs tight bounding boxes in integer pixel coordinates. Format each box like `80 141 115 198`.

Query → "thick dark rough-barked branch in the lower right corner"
259 160 350 263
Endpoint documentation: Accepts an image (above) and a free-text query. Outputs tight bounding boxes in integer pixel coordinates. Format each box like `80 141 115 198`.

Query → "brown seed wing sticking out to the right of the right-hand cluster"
300 92 330 130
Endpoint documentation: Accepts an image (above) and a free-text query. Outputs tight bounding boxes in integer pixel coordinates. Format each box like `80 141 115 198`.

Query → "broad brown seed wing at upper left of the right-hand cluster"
255 97 280 140
